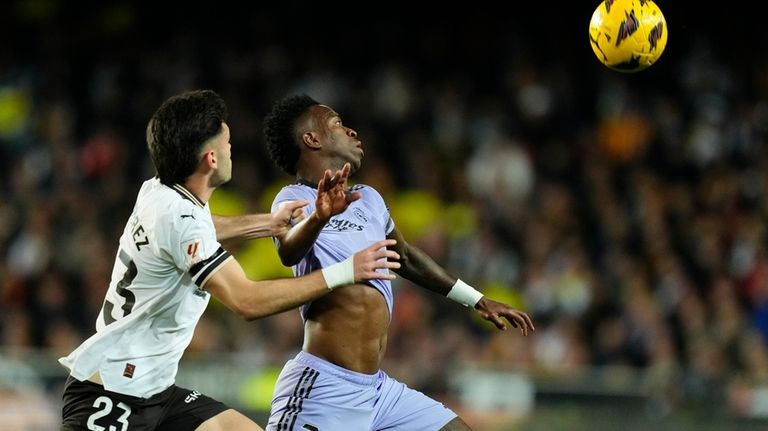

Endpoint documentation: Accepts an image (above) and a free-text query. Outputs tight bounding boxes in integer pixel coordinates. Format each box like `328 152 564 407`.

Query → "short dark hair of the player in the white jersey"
147 90 227 185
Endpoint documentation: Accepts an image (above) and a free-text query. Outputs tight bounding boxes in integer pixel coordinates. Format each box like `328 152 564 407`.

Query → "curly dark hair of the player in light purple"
264 94 320 175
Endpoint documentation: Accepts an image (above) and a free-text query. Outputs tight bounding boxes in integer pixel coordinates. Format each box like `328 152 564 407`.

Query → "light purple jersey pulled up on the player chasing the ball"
272 183 395 319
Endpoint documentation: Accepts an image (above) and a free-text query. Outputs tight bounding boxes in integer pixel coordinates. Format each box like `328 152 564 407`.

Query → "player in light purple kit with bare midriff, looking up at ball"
264 95 534 431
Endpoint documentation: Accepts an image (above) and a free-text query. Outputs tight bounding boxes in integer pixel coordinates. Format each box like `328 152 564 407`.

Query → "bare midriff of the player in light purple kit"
303 284 389 374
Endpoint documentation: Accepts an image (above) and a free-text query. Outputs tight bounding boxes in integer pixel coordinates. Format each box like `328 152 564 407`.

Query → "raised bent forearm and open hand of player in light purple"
275 163 360 266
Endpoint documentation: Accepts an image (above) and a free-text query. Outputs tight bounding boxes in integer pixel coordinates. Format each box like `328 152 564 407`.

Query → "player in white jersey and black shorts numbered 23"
60 90 399 431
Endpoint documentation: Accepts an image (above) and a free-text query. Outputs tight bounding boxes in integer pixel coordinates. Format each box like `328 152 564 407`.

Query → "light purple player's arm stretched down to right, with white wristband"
388 228 535 335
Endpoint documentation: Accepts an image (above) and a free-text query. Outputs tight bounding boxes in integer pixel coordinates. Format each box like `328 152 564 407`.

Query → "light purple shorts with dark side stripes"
266 351 456 431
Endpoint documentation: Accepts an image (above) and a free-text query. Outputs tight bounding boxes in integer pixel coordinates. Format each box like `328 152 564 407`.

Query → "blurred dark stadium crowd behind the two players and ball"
0 0 768 431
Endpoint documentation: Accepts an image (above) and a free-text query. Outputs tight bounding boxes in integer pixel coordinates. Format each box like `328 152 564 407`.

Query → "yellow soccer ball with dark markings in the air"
589 0 667 72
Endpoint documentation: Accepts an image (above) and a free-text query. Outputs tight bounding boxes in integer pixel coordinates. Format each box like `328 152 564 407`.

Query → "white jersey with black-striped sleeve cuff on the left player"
59 178 231 398
